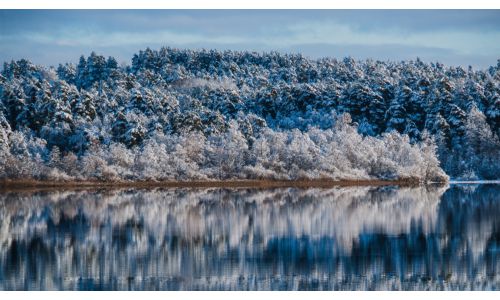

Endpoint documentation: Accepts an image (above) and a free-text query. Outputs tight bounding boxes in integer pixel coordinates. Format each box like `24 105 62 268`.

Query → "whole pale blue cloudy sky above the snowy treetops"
0 10 500 69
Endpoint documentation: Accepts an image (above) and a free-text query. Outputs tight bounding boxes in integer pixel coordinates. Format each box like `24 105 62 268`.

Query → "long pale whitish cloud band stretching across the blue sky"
4 21 500 55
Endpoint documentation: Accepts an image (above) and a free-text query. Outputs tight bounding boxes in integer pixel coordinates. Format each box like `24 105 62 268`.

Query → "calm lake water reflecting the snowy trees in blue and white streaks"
0 185 500 290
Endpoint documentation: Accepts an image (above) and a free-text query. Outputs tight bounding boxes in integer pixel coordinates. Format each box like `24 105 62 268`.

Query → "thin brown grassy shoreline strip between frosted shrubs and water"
0 178 446 191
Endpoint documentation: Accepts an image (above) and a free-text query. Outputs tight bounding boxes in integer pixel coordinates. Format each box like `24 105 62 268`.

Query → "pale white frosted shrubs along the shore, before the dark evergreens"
1 110 447 182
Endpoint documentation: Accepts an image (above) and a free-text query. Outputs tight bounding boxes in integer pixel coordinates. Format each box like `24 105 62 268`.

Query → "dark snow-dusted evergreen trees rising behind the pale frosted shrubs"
0 48 500 178
